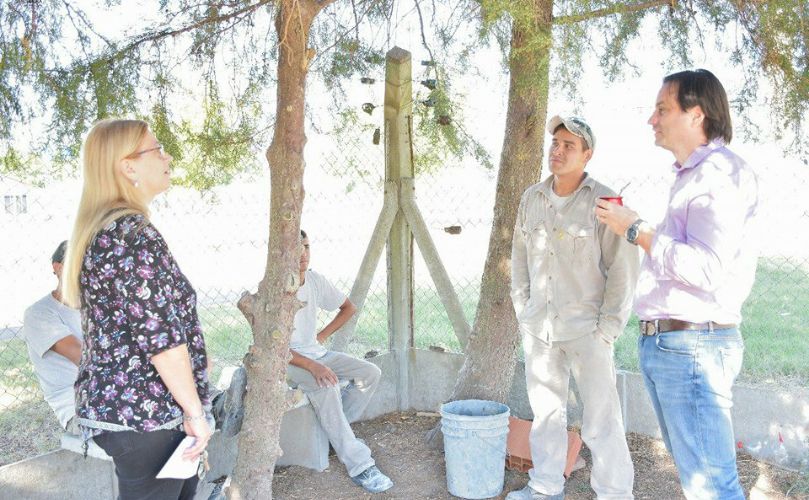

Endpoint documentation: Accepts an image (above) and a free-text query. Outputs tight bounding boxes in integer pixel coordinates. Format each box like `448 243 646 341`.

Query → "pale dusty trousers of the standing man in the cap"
523 334 634 500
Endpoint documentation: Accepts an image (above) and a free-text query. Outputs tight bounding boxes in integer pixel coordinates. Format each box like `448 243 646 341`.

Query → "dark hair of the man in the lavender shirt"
663 69 733 144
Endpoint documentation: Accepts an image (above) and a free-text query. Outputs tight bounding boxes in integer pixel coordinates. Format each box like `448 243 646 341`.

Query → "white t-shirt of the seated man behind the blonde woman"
22 294 82 428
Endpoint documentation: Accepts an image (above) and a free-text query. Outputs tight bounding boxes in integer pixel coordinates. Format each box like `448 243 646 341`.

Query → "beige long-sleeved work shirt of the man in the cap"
511 175 640 343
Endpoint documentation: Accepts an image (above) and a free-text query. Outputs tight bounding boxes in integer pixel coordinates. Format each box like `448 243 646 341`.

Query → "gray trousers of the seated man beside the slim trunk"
287 351 382 477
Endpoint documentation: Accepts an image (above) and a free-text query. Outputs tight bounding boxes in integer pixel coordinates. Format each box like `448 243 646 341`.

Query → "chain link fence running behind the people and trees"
0 97 809 465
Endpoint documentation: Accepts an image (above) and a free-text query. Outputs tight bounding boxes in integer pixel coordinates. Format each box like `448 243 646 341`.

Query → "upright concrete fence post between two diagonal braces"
385 47 413 410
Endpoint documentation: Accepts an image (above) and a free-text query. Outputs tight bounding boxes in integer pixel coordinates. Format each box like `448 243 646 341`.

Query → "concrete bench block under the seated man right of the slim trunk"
275 380 350 471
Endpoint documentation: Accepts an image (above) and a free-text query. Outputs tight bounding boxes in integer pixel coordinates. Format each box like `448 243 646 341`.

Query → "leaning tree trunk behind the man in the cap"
450 0 553 402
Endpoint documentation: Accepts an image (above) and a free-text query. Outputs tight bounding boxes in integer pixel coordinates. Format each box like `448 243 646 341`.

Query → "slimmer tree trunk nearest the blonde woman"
228 0 330 500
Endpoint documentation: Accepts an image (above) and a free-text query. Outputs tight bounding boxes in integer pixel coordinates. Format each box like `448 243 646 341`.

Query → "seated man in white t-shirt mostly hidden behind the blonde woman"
22 241 82 434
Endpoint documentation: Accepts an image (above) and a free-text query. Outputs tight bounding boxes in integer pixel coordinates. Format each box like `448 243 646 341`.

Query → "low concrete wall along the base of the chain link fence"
0 349 809 500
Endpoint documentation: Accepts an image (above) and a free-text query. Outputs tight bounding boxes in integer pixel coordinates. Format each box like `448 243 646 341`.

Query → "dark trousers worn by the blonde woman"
93 430 199 500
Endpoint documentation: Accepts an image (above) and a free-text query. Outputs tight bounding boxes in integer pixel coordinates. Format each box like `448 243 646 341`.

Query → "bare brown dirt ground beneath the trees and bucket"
273 412 809 500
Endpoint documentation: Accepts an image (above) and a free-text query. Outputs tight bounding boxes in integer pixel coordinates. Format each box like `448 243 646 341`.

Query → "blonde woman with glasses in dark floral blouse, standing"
63 120 211 499
